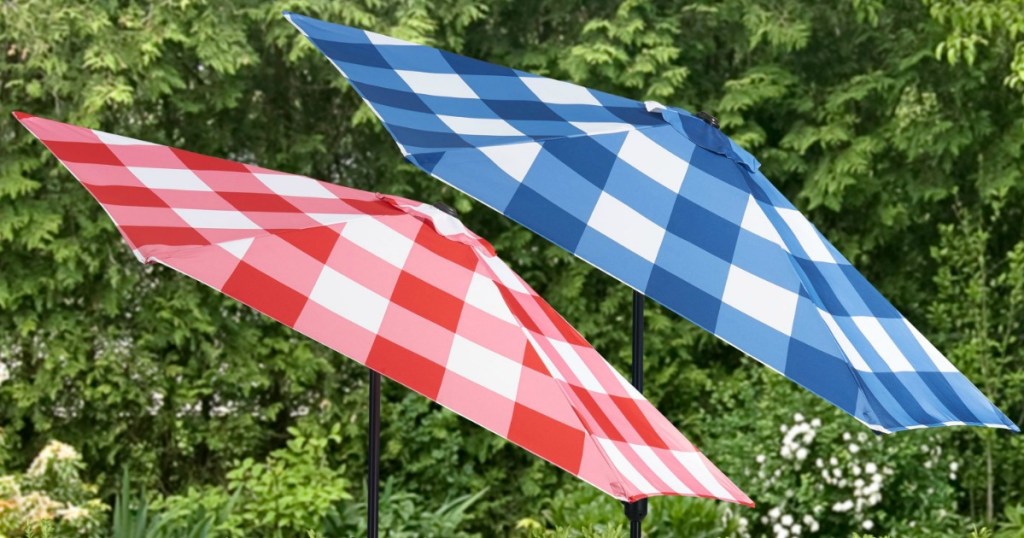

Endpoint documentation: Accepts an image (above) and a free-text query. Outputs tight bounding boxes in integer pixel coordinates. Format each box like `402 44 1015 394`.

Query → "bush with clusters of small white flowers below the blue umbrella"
749 413 961 538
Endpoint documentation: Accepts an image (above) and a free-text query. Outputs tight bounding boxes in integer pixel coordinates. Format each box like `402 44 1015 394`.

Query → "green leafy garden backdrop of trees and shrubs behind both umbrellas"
0 0 1024 538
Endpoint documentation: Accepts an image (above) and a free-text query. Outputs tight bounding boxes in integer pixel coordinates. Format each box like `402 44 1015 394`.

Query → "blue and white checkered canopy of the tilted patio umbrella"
286 14 1018 431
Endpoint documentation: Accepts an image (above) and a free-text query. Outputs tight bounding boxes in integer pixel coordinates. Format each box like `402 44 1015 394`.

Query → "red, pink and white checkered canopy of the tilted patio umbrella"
15 114 753 504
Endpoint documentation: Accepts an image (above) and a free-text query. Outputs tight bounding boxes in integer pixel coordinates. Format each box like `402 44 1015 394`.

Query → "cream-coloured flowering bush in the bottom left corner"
0 441 106 538
